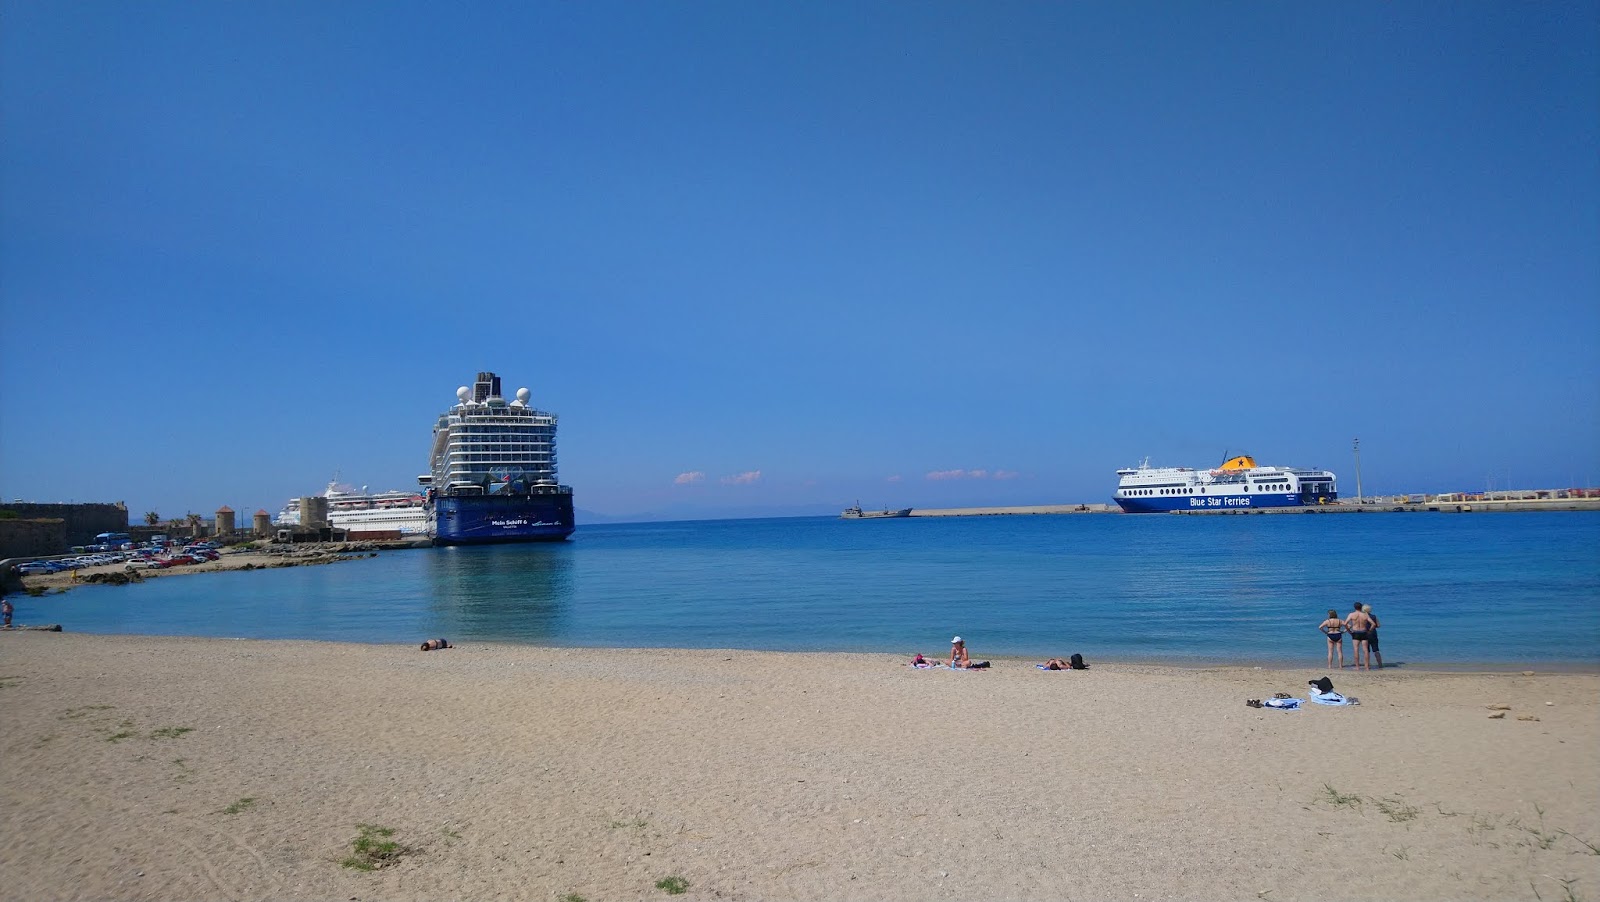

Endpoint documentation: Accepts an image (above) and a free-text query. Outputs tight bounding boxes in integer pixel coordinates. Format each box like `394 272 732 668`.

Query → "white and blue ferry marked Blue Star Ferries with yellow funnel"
1117 454 1339 513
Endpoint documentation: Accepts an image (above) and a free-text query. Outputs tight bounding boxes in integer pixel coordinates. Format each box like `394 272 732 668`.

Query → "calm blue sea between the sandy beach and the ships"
14 512 1600 670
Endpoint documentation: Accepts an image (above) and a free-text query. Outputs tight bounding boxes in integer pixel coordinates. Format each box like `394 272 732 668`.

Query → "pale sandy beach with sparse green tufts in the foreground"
0 632 1600 900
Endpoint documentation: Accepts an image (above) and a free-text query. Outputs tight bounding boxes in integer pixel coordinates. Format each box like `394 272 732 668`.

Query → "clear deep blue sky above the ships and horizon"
0 0 1600 521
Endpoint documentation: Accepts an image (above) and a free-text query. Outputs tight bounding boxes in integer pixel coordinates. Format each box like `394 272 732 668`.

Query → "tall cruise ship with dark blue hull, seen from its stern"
418 373 573 545
